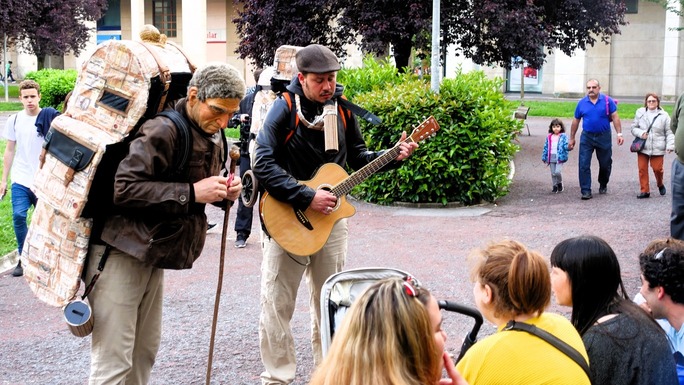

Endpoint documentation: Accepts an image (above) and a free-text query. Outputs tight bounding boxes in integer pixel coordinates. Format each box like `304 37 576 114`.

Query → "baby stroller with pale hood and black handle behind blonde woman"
321 267 483 362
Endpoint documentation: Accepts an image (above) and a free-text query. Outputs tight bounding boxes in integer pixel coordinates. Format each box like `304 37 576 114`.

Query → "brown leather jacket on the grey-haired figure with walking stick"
101 99 224 269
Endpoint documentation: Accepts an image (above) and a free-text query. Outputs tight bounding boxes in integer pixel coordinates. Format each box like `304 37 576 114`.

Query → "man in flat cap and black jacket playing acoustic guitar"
253 44 418 385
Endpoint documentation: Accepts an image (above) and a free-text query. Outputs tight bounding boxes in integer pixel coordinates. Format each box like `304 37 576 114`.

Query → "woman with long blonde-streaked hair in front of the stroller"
309 277 467 385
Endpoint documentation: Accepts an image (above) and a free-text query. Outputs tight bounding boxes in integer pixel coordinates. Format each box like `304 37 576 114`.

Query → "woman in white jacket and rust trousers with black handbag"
630 93 674 199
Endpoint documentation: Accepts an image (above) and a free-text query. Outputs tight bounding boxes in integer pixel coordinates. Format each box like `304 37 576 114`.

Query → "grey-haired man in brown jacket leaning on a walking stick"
86 63 245 385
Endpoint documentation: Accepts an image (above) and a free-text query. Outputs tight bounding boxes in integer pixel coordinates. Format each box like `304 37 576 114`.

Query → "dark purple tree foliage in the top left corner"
0 0 107 63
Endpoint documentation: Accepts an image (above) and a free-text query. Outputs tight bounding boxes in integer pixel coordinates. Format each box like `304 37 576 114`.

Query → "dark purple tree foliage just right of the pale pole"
442 0 626 68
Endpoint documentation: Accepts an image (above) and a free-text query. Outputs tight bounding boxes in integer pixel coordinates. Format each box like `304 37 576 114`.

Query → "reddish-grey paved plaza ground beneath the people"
0 113 674 385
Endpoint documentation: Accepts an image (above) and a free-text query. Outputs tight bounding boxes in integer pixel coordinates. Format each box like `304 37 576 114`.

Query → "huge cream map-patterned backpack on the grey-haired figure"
21 27 195 306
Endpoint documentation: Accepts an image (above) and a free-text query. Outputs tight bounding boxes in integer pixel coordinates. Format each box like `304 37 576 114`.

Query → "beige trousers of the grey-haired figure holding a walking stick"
86 245 164 385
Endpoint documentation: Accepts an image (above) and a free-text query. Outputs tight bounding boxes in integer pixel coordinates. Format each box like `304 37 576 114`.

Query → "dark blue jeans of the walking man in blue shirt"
579 130 613 193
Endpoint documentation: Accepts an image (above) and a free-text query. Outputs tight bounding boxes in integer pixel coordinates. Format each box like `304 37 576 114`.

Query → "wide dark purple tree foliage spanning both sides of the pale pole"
234 0 626 68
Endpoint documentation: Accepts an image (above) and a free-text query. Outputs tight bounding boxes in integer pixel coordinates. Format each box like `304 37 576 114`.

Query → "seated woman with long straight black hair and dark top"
551 236 678 385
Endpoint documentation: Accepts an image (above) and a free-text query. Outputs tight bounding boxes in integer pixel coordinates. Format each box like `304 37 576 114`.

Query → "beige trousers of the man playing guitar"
259 219 348 385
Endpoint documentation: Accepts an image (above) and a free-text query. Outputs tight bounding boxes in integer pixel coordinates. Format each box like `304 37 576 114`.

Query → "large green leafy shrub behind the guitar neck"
352 67 522 205
